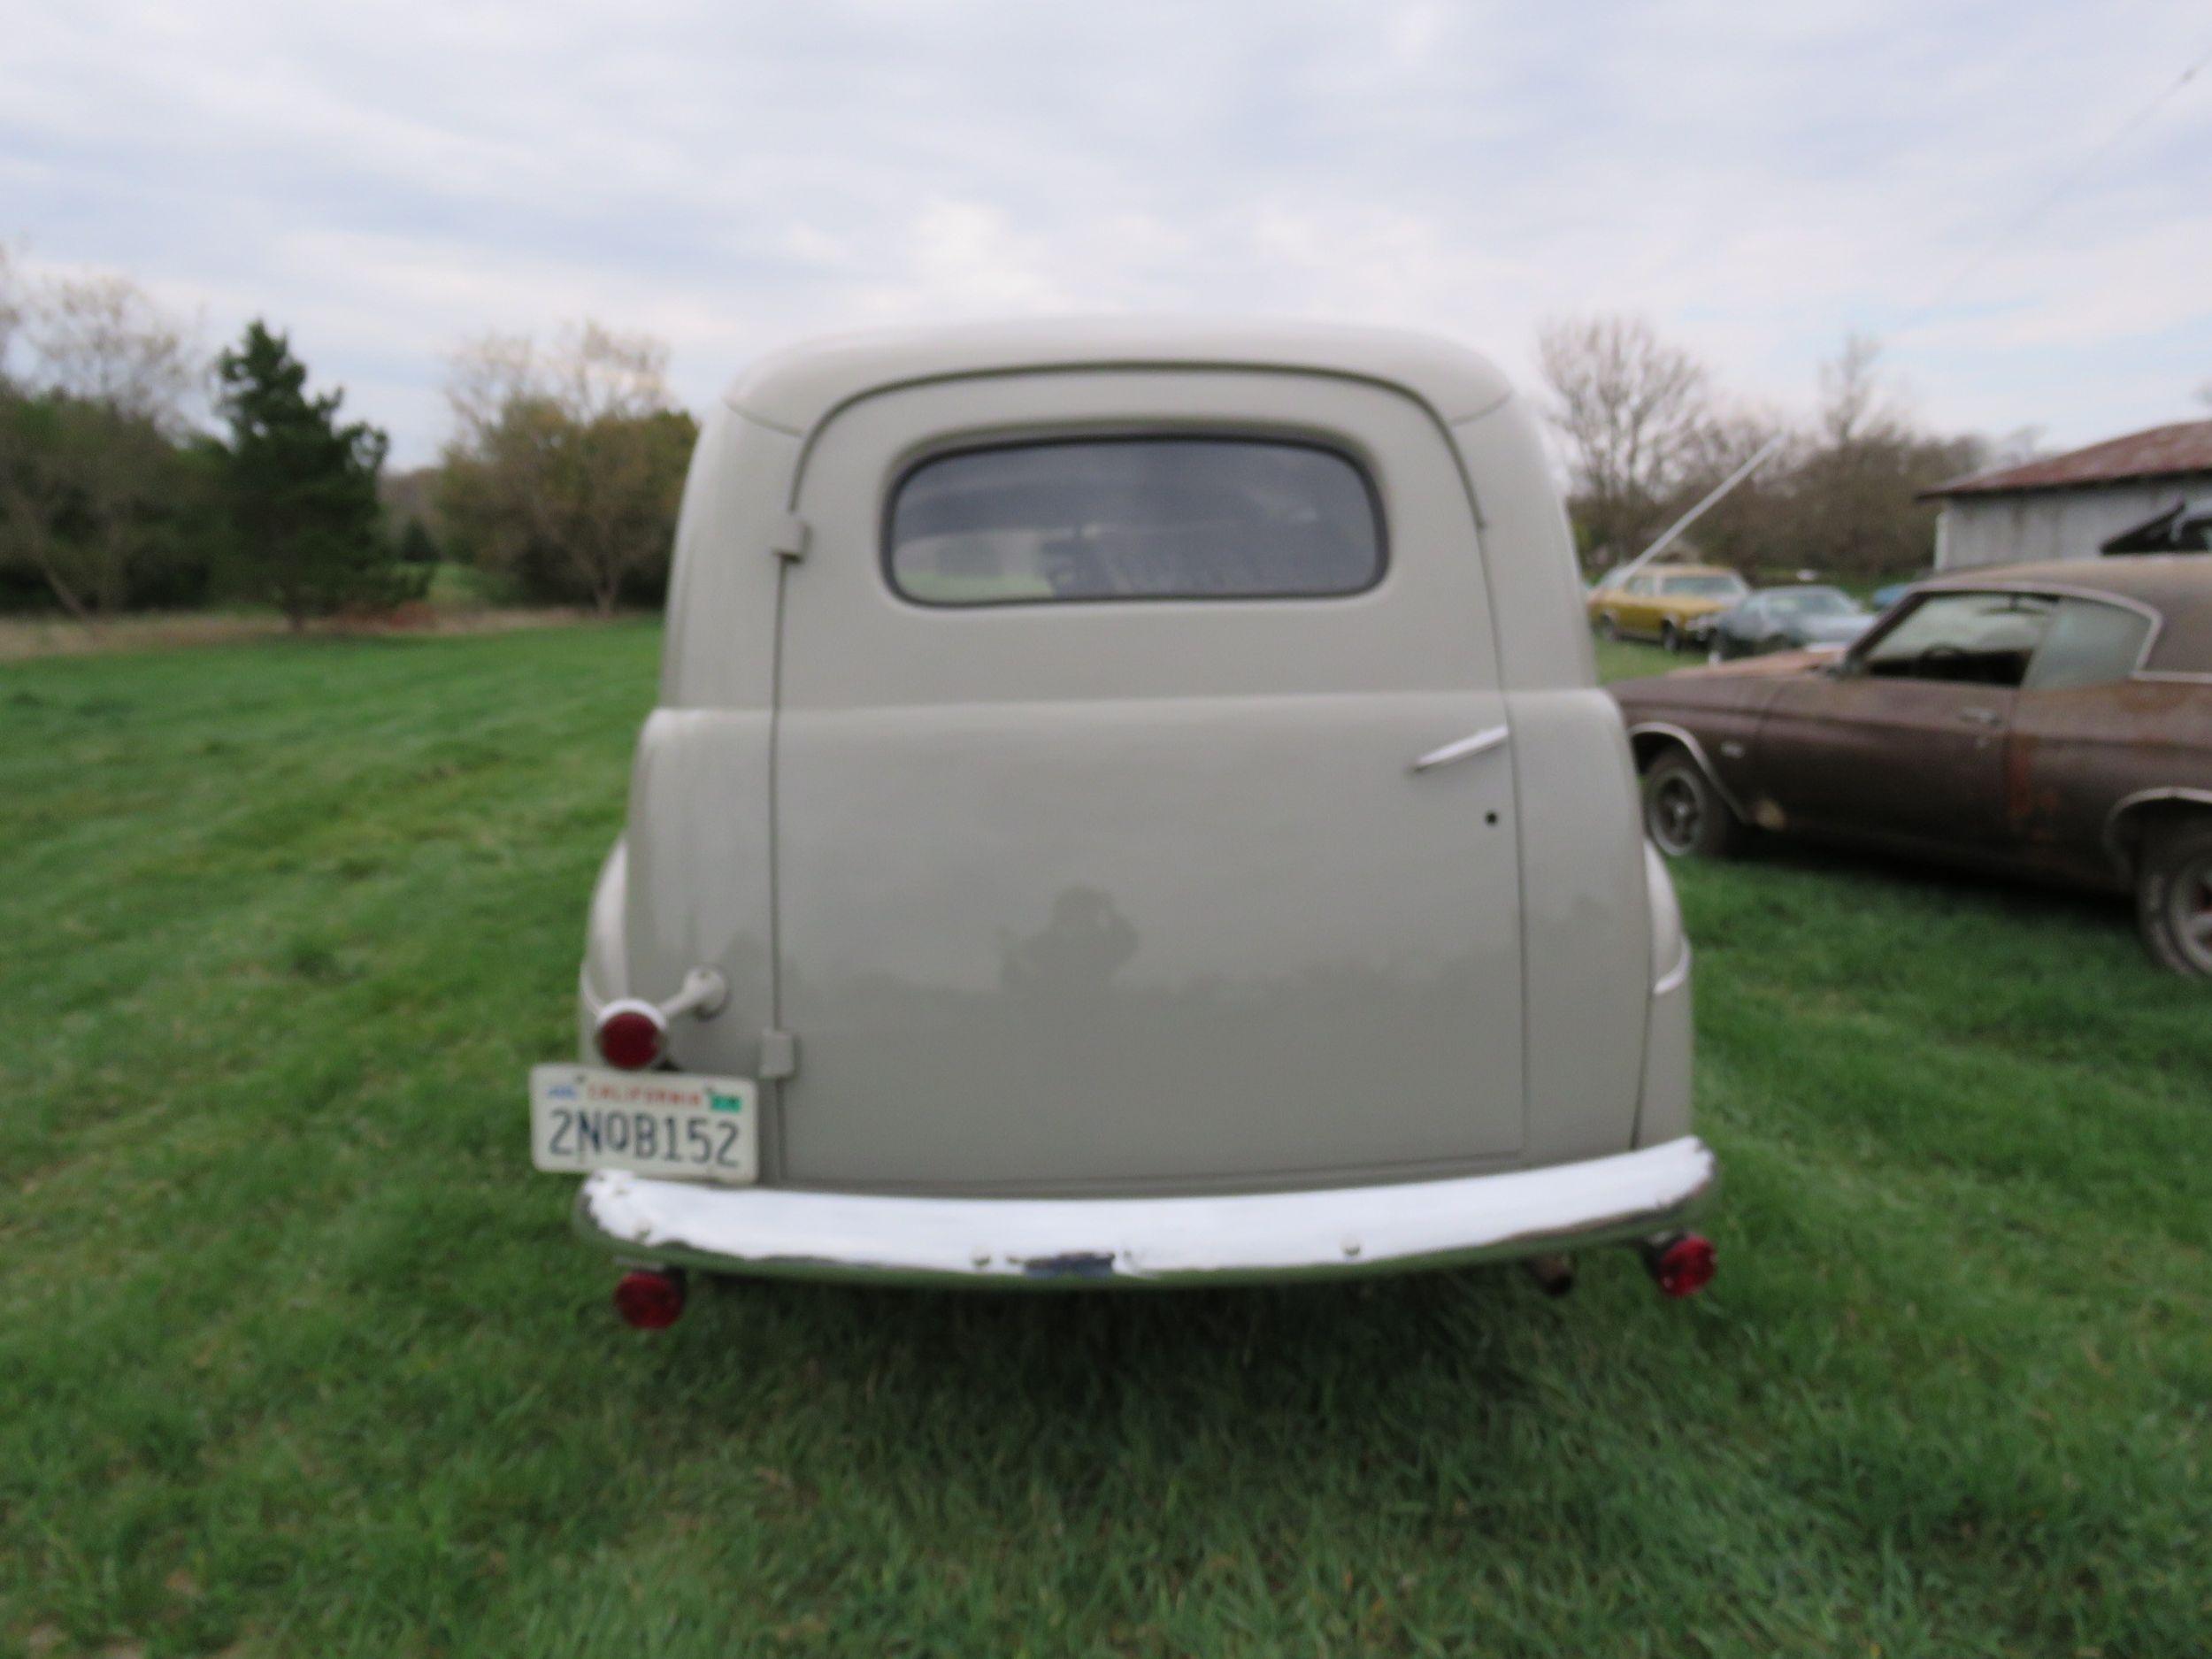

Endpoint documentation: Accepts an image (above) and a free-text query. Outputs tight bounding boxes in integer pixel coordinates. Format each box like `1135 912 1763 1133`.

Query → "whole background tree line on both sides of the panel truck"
0 250 2035 624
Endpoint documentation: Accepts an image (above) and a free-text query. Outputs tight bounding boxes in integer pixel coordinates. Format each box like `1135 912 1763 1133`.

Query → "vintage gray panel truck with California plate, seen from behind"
531 323 1715 1325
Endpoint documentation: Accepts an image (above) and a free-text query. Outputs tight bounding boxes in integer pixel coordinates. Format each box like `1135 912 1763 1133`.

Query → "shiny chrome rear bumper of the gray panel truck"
578 1135 1715 1283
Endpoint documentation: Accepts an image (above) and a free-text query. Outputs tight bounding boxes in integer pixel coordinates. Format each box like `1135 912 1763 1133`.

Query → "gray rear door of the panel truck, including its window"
774 370 1525 1193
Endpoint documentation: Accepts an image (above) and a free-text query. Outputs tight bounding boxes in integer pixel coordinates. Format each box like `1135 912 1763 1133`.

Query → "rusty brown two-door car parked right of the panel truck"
1613 556 2212 978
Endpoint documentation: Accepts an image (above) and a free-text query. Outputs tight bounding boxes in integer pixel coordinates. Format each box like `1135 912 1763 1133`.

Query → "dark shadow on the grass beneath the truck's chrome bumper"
619 1252 1693 1507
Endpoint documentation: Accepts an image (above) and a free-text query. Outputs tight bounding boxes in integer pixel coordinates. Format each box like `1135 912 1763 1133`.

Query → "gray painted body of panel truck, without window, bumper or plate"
582 323 1690 1197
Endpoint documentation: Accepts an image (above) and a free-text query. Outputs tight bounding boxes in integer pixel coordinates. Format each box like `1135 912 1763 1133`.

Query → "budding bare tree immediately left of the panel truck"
441 321 695 615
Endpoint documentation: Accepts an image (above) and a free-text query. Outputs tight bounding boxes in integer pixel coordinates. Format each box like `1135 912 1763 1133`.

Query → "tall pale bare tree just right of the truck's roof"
1538 317 1710 557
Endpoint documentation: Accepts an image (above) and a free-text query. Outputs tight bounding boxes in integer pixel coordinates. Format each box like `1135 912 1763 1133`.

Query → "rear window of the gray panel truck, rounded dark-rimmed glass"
885 438 1383 604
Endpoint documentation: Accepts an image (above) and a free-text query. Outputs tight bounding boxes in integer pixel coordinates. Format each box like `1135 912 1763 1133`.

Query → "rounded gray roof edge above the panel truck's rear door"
724 317 1511 434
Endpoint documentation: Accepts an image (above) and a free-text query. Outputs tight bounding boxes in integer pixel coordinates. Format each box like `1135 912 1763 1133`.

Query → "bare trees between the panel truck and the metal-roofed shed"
1538 317 2033 578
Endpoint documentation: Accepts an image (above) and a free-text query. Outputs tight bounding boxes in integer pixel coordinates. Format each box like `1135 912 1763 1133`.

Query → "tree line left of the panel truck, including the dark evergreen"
0 250 697 626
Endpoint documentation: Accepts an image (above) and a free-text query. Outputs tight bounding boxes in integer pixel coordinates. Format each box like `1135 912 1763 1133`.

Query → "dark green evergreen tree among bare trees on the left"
217 319 423 628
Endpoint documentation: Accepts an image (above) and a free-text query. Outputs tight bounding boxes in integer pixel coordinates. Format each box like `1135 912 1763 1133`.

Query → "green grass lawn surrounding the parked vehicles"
0 624 2212 1659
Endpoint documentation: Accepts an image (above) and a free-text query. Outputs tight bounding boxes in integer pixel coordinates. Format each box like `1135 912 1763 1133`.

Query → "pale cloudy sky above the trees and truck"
0 0 2212 463
